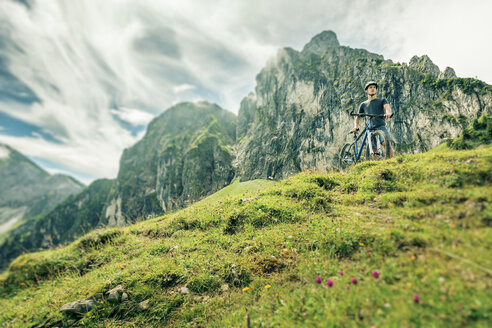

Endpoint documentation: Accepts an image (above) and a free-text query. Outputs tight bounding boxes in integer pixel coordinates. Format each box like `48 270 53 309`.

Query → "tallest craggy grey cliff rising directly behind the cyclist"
234 32 492 180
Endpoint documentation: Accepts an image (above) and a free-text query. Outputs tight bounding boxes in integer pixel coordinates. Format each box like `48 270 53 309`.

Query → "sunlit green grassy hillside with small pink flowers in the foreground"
0 147 492 327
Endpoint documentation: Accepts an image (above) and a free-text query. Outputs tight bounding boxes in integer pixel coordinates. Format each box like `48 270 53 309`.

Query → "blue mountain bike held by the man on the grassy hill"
340 112 393 169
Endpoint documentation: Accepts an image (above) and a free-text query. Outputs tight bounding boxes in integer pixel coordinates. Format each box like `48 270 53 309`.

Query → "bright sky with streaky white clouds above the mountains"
0 0 492 183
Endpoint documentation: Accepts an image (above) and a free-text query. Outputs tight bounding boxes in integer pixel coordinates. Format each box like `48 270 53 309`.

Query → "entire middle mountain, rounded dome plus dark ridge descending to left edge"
0 102 236 269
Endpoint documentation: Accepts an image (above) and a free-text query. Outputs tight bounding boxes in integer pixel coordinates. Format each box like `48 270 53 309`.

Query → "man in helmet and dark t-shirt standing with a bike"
352 81 394 157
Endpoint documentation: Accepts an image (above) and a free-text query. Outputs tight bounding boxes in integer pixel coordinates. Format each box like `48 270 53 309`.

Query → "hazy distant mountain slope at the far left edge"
0 144 84 234
